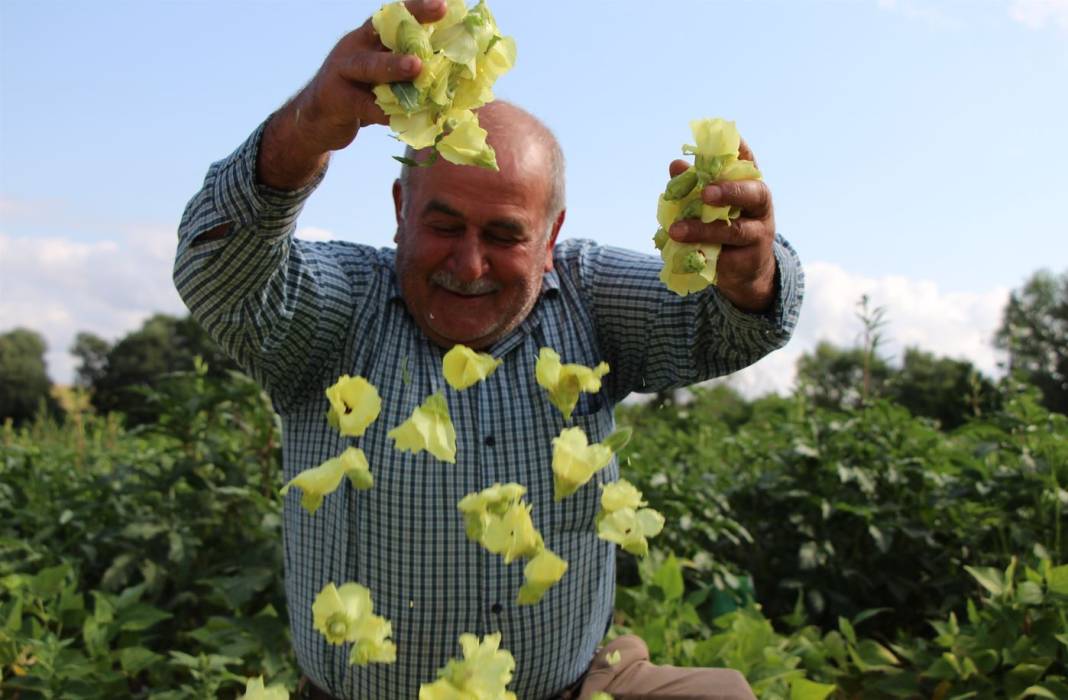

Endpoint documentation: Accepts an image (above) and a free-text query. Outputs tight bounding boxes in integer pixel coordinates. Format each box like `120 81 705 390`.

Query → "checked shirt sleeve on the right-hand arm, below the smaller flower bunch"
577 236 804 401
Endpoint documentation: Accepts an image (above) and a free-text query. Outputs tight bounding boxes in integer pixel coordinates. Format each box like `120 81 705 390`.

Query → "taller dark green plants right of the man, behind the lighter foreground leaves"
621 382 1068 637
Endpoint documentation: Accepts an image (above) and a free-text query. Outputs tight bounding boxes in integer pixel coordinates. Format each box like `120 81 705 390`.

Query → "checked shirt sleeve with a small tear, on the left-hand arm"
174 125 371 410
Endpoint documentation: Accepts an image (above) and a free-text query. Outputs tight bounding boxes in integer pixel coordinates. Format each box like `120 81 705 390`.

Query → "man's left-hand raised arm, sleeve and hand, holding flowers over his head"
174 0 445 406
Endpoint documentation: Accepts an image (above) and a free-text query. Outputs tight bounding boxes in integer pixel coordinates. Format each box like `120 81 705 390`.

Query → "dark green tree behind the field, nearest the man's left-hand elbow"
92 313 237 425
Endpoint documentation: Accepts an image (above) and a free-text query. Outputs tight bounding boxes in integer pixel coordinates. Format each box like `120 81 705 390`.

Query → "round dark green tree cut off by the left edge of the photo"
0 328 58 425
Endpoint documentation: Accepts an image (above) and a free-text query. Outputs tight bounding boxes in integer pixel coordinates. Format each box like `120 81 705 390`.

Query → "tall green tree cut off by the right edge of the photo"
994 270 1068 414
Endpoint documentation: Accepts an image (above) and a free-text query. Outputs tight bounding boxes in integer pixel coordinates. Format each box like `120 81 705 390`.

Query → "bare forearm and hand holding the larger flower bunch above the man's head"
256 0 446 190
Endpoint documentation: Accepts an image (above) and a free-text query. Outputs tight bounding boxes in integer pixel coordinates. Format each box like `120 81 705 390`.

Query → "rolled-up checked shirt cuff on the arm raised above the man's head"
211 121 327 238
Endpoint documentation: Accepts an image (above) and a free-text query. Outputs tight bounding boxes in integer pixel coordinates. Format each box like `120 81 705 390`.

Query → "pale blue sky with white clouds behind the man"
0 0 1068 388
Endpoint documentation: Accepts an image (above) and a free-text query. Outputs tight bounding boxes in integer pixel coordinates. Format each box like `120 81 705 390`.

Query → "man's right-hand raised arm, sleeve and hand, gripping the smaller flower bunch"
578 137 804 406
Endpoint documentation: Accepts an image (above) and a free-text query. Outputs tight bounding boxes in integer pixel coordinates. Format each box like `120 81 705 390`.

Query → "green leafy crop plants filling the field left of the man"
0 365 297 698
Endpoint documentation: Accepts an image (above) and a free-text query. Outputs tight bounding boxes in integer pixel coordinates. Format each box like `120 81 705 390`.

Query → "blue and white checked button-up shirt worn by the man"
174 126 802 700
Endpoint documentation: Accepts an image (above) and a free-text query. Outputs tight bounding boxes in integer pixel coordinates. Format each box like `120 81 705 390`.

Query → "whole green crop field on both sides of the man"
0 363 1068 700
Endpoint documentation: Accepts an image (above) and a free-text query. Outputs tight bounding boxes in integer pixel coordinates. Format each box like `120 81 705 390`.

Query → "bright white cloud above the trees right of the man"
717 262 1009 396
